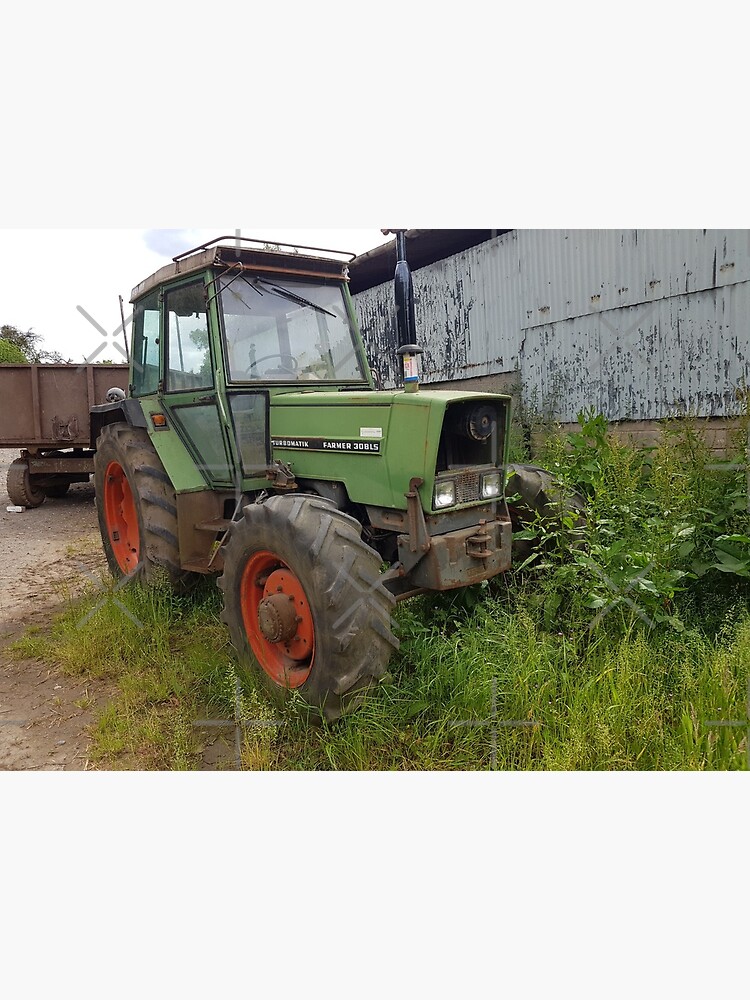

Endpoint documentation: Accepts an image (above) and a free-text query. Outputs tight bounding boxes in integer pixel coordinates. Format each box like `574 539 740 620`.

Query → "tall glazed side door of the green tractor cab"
161 276 236 486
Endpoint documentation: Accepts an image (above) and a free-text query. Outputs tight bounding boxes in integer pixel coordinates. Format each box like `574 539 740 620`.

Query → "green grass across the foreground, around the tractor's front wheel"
10 583 750 770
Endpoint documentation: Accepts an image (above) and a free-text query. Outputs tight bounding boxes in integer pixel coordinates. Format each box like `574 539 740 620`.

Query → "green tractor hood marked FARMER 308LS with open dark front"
270 390 510 510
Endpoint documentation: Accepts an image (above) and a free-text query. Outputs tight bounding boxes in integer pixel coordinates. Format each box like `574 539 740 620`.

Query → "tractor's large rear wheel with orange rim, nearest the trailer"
94 423 200 592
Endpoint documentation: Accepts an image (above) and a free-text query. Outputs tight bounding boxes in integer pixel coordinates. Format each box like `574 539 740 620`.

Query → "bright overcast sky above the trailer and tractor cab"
0 227 392 362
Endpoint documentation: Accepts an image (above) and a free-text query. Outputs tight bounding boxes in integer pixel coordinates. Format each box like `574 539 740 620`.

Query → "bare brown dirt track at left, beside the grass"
0 450 108 771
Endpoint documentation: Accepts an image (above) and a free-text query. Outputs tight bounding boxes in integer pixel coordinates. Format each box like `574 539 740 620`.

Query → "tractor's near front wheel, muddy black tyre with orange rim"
219 496 399 722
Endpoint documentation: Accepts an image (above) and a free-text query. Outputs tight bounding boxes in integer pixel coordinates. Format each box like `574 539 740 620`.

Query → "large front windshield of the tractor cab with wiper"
219 272 366 383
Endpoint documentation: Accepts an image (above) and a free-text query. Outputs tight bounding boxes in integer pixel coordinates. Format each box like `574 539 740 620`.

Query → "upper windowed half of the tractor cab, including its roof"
132 238 372 395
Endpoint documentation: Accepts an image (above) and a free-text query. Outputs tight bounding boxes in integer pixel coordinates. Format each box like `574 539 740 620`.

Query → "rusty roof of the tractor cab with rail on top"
130 236 354 302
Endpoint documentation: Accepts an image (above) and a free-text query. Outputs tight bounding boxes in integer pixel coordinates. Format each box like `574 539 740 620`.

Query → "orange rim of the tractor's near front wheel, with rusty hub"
240 551 315 689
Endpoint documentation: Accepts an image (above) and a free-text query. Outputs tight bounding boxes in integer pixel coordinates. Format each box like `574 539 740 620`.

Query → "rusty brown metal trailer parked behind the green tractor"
0 364 128 507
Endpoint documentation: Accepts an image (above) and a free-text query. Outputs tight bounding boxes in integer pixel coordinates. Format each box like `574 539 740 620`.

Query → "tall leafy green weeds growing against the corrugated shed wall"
522 412 750 631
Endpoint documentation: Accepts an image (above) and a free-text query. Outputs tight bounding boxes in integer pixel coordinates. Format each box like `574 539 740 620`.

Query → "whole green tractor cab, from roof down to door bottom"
125 237 373 490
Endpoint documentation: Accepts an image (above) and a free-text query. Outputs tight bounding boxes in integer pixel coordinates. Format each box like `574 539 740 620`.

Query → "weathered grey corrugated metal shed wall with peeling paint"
355 229 750 421
